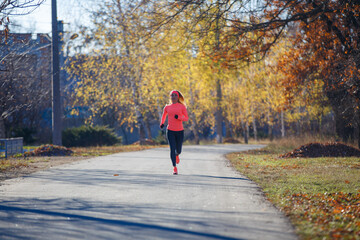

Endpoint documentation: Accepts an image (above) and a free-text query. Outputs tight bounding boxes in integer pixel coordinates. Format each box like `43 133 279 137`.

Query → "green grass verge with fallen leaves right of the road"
227 141 360 239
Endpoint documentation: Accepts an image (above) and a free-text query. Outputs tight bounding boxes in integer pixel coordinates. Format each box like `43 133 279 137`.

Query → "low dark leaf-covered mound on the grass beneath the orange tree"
280 143 360 158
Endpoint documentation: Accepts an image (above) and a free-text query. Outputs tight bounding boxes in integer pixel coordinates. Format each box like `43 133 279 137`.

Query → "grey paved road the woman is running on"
0 145 296 240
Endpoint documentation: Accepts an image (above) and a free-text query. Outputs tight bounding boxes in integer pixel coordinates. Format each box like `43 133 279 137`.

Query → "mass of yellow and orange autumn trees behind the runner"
67 0 360 143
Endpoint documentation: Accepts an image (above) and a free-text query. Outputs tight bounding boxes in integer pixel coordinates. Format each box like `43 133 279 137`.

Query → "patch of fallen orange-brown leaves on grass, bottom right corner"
282 192 360 239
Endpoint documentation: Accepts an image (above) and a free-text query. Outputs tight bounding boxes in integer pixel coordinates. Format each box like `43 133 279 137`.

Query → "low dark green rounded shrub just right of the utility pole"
62 126 121 147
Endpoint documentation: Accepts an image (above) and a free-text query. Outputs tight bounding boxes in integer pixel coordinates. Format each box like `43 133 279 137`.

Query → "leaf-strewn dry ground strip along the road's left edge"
0 156 90 185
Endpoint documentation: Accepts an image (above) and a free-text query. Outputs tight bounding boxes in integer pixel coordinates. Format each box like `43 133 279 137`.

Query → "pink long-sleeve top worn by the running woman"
160 103 189 131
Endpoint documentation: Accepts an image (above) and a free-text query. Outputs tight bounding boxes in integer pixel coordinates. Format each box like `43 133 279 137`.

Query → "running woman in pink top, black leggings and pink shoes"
160 90 189 175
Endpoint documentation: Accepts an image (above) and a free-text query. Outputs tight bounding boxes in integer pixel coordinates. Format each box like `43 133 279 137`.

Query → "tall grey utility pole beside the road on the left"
51 0 62 145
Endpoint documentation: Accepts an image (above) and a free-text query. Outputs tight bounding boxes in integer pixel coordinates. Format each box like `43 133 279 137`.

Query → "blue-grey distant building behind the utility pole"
0 21 88 132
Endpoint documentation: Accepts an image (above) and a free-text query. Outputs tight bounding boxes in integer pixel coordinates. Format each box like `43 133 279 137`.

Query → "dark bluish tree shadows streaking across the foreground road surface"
0 198 286 240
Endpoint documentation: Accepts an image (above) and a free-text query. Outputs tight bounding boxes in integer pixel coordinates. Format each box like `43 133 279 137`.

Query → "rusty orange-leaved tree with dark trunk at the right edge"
272 1 360 141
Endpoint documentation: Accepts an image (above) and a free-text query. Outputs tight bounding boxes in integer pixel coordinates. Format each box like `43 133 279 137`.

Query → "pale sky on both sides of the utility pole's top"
10 0 97 34
